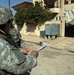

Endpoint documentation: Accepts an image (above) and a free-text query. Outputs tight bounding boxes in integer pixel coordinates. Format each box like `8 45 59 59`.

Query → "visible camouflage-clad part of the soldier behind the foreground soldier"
9 25 21 47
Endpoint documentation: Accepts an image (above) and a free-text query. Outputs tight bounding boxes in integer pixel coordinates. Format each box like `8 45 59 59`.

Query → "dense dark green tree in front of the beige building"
15 4 53 24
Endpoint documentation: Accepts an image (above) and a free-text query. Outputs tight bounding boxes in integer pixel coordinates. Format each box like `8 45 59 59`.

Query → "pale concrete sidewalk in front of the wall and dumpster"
22 35 74 51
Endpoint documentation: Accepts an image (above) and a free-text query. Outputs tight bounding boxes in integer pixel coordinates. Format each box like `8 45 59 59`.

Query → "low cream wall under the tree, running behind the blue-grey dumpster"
15 21 61 37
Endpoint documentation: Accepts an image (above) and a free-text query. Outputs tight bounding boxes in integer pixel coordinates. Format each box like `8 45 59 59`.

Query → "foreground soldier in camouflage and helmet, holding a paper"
0 5 38 75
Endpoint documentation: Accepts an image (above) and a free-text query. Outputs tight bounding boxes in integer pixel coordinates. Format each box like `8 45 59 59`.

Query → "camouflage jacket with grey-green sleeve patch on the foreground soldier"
0 30 37 75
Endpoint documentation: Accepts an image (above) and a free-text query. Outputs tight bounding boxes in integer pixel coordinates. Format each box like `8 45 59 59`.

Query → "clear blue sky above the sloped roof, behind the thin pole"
0 0 32 14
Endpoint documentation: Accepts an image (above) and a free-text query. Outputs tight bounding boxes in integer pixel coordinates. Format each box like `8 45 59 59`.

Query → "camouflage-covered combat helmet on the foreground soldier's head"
0 5 13 25
